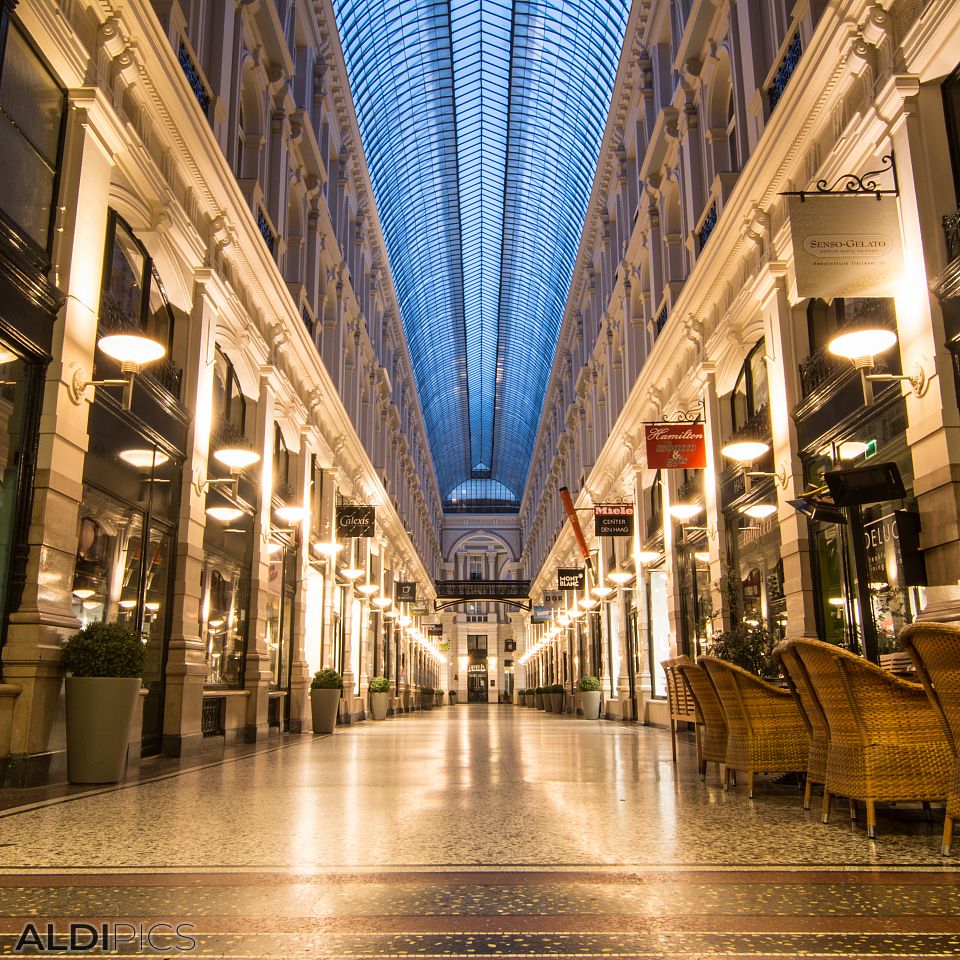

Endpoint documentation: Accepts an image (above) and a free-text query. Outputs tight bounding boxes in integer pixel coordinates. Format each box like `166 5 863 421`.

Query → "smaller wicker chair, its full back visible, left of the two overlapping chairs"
700 657 810 798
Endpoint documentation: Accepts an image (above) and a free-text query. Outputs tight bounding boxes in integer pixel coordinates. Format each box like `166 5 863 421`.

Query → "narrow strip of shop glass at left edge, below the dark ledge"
0 344 33 632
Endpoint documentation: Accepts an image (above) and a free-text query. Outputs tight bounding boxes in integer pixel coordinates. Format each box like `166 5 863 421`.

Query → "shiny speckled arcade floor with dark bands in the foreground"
0 705 960 958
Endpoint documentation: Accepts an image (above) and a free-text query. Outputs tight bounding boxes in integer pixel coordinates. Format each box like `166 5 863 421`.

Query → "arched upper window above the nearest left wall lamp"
100 210 174 355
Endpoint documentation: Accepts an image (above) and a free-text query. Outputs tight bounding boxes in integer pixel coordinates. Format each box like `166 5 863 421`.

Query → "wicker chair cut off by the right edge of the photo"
900 623 960 857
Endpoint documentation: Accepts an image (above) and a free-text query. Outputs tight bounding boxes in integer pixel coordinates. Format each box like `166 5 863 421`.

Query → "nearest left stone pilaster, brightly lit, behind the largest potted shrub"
3 90 121 786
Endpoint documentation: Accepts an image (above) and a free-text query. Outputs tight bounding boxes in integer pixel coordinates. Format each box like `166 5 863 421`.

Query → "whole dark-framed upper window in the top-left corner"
0 19 65 253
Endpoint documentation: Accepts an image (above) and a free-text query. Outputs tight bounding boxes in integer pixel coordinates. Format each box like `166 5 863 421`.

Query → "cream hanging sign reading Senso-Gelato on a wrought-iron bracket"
787 194 903 298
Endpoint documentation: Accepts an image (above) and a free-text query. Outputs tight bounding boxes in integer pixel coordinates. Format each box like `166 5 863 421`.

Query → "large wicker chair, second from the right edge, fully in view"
794 640 953 839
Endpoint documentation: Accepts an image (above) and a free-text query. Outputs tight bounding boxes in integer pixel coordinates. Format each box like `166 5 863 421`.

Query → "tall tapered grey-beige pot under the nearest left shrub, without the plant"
66 677 140 783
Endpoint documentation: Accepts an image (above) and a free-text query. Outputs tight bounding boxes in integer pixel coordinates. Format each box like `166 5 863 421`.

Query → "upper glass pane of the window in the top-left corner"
0 24 63 164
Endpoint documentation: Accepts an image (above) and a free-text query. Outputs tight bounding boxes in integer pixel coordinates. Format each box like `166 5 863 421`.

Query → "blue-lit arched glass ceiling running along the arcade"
333 0 630 503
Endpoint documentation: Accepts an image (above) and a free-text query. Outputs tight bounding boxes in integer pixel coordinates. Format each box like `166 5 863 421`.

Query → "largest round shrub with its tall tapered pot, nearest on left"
63 622 144 783
